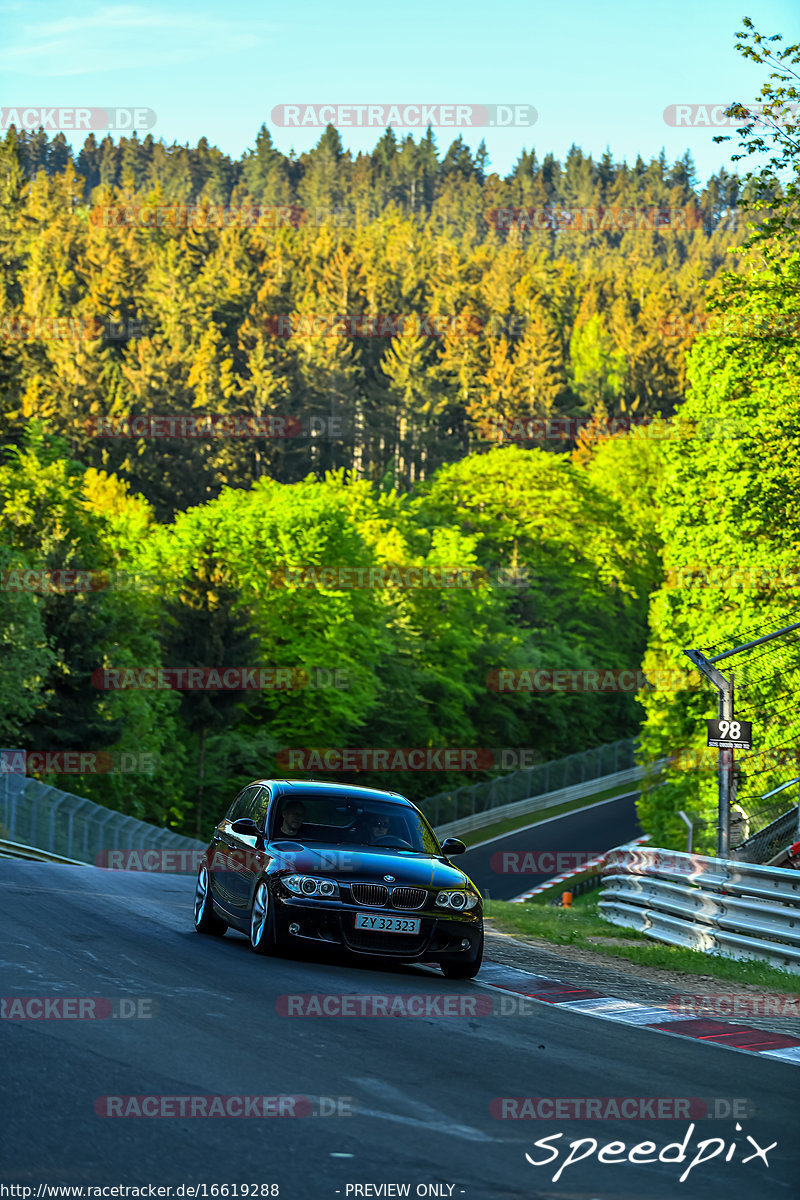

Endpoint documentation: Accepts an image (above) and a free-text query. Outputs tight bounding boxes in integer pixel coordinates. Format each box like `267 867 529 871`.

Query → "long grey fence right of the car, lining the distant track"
417 738 636 828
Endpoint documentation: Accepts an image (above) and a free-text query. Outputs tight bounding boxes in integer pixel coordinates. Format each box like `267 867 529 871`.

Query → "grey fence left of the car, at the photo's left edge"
0 774 205 863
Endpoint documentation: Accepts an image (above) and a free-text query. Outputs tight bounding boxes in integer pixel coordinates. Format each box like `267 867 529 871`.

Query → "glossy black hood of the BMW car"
267 840 471 888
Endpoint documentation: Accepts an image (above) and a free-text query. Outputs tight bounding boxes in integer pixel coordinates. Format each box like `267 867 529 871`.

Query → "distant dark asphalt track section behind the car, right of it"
457 792 642 900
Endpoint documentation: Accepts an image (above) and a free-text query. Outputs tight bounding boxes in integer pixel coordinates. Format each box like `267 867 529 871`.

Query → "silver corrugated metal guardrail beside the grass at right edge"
600 846 800 973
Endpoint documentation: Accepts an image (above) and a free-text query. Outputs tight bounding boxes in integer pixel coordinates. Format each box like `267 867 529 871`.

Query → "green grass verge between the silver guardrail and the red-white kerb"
486 892 800 995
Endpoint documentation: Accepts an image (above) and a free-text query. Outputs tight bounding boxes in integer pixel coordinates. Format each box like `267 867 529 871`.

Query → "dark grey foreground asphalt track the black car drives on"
0 860 800 1200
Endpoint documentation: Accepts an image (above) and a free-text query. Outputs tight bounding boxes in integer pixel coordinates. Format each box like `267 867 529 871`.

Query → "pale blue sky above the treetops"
0 0 800 180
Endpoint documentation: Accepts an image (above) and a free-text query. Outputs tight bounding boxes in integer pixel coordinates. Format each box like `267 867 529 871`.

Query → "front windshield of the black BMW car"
272 793 440 854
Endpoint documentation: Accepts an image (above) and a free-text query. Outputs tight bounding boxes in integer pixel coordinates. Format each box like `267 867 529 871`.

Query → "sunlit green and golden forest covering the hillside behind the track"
0 18 800 845
